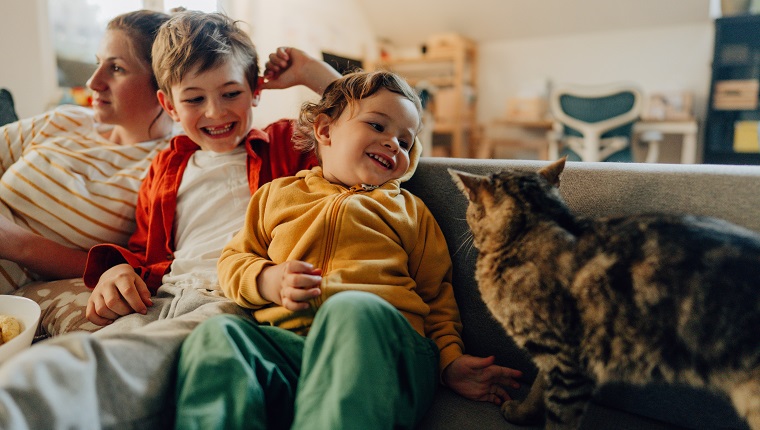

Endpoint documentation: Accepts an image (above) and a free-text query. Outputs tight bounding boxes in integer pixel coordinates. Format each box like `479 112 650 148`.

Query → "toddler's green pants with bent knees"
176 291 438 430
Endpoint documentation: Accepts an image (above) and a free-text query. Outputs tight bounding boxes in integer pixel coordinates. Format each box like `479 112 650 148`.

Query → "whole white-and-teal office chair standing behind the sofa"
548 83 642 162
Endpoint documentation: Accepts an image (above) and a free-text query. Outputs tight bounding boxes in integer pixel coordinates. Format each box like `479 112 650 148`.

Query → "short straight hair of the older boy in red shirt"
153 11 259 97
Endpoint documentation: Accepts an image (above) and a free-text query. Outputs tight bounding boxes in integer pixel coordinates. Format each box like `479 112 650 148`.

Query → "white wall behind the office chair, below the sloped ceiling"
478 23 714 122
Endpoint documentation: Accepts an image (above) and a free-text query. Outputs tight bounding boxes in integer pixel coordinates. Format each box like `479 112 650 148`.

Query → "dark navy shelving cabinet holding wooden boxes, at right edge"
703 15 760 164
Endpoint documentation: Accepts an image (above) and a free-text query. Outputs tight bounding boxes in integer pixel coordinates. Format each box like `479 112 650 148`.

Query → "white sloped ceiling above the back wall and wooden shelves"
357 0 711 47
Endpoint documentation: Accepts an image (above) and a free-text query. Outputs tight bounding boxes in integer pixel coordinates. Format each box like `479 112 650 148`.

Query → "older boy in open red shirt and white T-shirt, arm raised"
0 12 338 429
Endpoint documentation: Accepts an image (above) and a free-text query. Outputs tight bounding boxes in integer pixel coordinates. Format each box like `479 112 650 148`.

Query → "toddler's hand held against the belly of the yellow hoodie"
258 260 322 311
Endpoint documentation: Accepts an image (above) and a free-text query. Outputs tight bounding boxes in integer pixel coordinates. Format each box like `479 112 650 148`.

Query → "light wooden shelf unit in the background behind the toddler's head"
370 35 478 157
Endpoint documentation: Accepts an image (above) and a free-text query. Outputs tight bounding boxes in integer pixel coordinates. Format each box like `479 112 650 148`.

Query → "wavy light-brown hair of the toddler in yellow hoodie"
293 70 422 156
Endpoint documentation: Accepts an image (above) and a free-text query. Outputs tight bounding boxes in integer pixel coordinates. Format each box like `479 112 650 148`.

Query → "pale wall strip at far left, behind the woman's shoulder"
0 0 58 118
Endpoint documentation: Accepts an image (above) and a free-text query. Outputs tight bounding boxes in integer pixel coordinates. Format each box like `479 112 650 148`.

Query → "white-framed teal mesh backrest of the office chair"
549 82 642 161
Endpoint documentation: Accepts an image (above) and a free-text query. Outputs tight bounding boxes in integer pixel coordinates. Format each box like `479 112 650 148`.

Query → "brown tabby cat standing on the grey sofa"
450 159 760 430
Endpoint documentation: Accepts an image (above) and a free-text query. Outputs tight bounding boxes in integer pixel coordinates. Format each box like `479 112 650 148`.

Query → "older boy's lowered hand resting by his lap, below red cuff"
85 264 153 325
